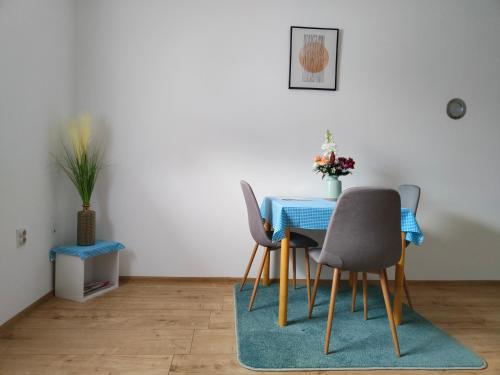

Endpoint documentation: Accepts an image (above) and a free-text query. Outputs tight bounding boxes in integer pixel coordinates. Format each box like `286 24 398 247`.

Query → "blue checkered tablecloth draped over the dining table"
260 197 424 245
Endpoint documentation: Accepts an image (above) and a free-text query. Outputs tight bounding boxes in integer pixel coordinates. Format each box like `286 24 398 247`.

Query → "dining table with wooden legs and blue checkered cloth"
260 196 424 327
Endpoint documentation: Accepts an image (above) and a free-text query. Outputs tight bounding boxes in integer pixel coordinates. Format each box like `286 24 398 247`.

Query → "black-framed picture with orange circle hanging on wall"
288 26 339 91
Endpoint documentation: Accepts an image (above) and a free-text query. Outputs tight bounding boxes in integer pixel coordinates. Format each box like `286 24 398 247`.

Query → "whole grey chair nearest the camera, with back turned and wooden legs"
309 187 401 357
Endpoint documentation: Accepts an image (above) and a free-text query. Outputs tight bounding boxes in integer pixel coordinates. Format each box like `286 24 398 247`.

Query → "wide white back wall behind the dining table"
71 0 500 279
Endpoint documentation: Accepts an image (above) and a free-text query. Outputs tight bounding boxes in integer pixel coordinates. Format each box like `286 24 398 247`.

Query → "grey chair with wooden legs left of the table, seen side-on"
240 181 318 311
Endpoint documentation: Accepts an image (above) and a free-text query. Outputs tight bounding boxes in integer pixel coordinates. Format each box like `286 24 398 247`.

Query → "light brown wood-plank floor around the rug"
0 280 500 375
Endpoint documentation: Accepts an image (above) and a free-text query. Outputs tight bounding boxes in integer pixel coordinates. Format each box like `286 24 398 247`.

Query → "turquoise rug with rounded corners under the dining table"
234 284 486 371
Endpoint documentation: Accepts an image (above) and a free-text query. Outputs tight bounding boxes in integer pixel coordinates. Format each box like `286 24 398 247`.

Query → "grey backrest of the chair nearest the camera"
319 187 401 272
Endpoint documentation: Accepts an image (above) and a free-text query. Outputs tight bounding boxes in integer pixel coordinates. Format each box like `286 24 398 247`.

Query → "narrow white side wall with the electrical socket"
0 0 74 324
